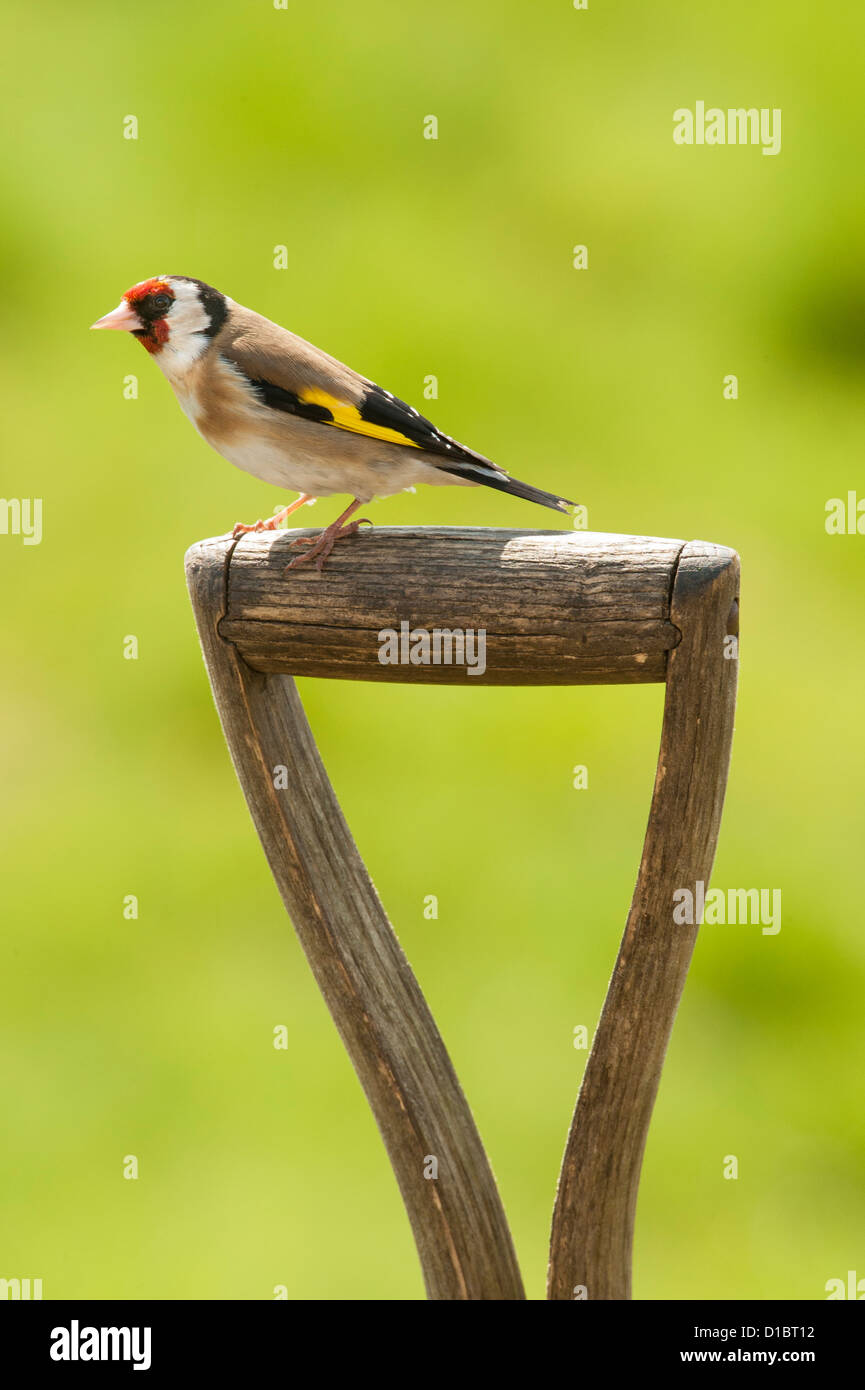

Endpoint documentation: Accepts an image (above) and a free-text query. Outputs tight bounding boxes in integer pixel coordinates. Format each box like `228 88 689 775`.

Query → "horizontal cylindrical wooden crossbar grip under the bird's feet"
220 527 684 685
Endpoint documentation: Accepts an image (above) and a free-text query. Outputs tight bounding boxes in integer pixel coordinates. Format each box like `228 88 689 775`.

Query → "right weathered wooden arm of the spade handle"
548 542 738 1300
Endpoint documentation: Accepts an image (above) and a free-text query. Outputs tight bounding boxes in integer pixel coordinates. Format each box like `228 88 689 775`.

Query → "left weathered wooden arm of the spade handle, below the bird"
186 539 524 1300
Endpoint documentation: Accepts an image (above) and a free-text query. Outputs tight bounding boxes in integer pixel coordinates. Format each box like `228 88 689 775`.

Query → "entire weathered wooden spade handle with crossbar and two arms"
186 528 738 1300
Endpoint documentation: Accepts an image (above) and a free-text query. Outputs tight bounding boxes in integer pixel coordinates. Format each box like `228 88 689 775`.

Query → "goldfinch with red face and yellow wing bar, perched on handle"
92 275 574 571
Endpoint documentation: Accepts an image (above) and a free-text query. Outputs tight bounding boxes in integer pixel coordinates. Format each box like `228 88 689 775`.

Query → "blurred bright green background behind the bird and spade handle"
0 0 865 1298
